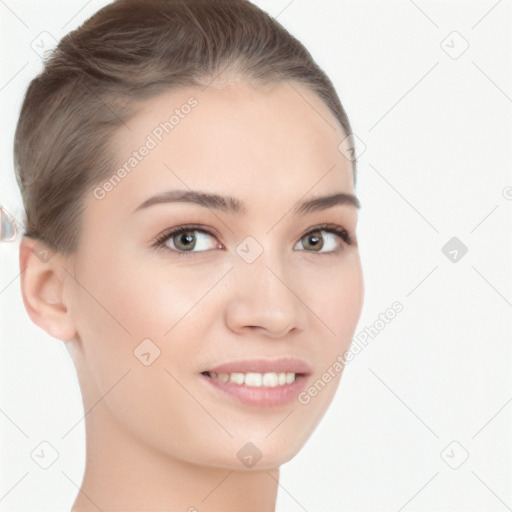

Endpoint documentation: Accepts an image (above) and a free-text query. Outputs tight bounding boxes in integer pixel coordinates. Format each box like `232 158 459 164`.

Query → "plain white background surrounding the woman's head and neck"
0 0 512 512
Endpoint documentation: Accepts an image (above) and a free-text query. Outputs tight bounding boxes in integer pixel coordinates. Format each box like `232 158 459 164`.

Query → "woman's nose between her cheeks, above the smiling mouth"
225 251 307 339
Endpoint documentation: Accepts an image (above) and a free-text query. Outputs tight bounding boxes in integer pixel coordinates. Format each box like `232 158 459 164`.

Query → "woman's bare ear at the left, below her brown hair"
19 236 77 341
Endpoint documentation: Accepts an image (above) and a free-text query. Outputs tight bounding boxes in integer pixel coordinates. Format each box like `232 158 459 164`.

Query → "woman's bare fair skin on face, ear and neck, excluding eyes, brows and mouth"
20 81 364 512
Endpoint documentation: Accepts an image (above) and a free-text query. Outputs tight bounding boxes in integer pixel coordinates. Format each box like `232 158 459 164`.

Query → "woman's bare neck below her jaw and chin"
72 408 279 512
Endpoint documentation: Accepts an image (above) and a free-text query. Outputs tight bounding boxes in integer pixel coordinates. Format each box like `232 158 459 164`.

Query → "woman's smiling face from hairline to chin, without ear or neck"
65 82 364 469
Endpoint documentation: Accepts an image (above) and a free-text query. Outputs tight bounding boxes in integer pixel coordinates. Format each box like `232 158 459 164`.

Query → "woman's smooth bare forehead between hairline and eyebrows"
93 82 353 216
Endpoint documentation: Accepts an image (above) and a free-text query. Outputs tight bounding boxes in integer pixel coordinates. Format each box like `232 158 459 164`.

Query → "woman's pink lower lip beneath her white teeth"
199 374 307 407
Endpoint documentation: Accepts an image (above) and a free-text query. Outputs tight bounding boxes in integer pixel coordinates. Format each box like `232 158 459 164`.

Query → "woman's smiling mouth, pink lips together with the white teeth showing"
200 358 313 407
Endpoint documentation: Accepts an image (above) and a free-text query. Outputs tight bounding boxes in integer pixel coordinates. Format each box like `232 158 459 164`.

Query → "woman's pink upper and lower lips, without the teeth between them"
200 357 313 407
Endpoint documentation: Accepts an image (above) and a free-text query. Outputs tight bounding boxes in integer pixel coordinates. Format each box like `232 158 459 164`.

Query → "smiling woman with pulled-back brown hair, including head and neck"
15 0 364 512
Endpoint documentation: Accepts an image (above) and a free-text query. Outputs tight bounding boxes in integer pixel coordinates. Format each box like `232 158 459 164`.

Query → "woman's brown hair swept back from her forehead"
14 0 356 255
